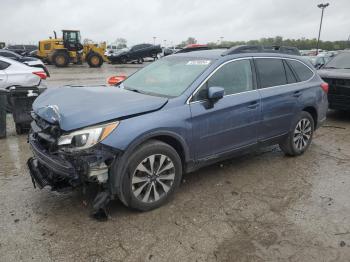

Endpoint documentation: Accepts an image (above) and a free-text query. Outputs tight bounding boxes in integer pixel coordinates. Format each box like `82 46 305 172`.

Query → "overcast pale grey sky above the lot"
0 0 350 45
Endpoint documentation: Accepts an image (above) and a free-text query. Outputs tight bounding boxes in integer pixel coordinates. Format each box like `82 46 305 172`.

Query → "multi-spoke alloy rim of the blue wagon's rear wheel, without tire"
293 118 312 151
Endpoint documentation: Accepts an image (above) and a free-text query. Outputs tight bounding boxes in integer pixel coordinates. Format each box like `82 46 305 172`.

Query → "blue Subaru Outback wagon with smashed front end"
28 50 328 213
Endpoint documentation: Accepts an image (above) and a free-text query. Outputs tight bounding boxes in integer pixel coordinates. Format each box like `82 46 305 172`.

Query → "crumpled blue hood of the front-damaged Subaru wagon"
33 86 168 131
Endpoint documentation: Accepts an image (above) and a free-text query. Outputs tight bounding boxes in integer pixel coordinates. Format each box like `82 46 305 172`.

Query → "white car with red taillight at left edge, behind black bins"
0 57 47 89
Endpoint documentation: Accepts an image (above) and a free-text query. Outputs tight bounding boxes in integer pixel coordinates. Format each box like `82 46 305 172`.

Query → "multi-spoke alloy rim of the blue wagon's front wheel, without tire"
131 154 175 203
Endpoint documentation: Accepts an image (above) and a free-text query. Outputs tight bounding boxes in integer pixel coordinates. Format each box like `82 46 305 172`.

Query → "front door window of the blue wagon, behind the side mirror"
193 59 254 101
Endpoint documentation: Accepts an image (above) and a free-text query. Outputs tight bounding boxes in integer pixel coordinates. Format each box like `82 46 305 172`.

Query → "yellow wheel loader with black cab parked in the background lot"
37 30 108 67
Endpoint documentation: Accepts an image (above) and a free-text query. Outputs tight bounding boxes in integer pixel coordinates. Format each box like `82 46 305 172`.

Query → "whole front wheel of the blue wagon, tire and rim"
119 140 182 211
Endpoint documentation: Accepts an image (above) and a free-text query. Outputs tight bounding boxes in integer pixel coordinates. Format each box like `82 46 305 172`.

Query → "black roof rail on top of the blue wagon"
222 45 301 56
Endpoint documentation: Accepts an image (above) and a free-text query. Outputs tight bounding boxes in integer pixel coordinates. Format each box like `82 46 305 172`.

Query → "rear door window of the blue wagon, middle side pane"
255 58 287 88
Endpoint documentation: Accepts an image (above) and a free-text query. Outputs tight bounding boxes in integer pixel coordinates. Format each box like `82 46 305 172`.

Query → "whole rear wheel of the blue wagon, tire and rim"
279 111 315 156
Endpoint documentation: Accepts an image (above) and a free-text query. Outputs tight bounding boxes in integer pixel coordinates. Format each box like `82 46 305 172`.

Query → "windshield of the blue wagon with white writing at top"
123 57 212 97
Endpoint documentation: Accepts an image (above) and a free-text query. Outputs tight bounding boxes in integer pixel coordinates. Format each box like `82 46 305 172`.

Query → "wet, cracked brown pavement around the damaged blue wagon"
0 65 350 262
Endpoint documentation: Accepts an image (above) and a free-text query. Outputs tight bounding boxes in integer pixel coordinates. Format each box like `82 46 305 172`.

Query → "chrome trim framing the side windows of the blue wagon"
186 56 316 104
